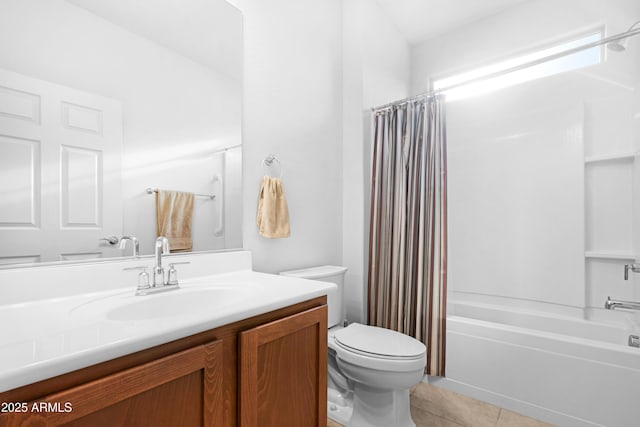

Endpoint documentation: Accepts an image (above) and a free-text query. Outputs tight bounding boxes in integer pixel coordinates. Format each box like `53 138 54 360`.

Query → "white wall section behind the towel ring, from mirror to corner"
232 0 342 272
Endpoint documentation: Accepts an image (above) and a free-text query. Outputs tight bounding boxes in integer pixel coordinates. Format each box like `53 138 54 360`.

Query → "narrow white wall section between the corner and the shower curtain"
342 0 410 321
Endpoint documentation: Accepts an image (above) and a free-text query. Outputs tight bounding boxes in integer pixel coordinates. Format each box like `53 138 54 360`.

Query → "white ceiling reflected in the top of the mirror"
67 0 242 79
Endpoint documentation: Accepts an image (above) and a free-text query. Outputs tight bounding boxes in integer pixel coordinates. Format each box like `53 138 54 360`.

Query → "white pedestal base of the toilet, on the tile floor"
346 383 416 427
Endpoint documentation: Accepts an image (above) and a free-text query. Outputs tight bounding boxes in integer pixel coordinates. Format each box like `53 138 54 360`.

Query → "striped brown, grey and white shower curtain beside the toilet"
368 95 447 376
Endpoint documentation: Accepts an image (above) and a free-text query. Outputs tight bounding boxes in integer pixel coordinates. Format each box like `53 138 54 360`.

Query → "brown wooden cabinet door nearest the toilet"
239 305 327 427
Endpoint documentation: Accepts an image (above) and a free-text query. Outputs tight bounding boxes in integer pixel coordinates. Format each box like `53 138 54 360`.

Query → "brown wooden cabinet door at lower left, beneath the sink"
0 341 223 427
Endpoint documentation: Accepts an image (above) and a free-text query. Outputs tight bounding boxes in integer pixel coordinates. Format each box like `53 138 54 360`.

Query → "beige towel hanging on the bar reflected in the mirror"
156 190 194 252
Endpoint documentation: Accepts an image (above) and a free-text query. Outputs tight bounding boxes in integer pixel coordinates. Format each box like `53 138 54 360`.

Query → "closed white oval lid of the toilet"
334 323 427 359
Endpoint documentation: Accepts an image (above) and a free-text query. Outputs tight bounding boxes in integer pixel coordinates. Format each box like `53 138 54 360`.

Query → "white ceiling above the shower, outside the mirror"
378 0 527 45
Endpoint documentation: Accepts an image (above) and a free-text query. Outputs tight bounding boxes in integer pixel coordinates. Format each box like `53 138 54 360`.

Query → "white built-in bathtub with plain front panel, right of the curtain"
428 301 640 427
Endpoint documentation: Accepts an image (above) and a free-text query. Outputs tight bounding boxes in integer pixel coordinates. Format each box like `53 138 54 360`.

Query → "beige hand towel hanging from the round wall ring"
256 176 291 239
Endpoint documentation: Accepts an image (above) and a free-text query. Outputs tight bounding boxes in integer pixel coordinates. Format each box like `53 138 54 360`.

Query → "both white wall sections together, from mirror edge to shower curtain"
231 0 410 320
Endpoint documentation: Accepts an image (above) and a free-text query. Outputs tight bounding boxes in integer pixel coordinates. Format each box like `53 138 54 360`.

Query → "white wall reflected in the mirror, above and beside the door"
0 0 241 253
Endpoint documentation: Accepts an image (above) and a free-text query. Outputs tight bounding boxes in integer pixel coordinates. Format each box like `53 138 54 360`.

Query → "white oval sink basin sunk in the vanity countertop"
71 284 258 321
